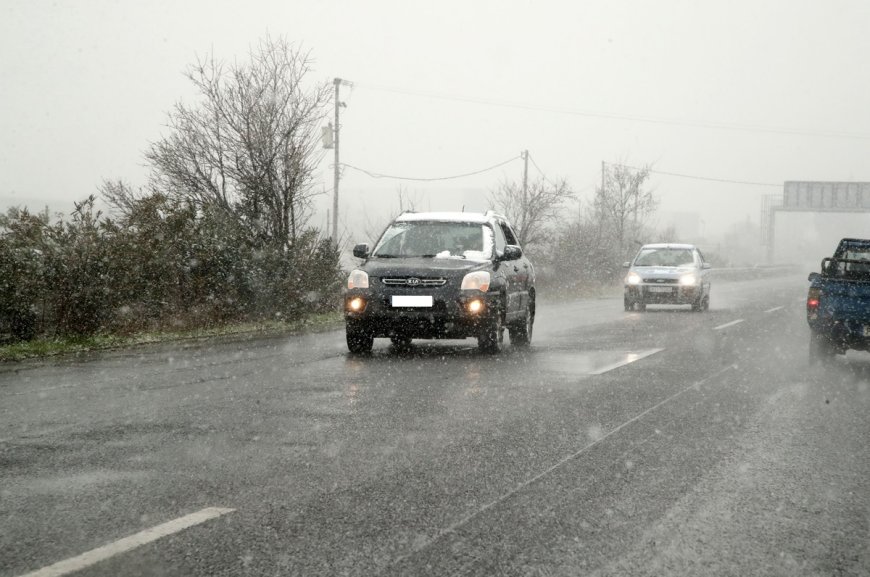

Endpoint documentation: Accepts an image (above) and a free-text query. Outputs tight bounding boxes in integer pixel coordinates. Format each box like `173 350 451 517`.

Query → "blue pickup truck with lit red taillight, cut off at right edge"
807 238 870 363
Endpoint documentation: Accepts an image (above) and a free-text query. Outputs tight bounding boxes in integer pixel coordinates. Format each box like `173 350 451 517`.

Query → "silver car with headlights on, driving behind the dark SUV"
623 244 711 311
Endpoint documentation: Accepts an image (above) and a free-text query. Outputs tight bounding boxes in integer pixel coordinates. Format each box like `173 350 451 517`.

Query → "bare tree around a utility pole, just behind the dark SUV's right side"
490 177 574 247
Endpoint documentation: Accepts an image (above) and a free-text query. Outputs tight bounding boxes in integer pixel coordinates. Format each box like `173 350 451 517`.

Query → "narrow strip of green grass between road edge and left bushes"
0 312 343 362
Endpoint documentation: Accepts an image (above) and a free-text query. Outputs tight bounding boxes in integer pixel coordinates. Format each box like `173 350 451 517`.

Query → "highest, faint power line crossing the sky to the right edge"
355 83 870 140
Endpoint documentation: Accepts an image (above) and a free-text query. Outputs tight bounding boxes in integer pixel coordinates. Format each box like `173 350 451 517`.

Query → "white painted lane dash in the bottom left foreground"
21 507 235 577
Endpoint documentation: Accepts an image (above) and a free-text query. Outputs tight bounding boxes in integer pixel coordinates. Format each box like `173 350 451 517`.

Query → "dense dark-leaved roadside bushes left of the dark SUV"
0 194 341 341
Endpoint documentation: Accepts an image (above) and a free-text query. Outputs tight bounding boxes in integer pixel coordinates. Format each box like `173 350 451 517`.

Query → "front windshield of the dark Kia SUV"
372 221 493 260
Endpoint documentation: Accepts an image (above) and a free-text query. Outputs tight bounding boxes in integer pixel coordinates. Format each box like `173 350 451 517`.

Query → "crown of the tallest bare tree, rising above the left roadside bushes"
146 38 331 247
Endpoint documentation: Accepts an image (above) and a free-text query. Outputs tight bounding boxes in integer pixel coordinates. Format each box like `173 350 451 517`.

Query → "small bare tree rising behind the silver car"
593 164 658 256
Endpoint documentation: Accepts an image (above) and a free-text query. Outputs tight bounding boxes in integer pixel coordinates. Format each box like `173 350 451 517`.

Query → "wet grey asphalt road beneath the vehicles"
0 276 870 577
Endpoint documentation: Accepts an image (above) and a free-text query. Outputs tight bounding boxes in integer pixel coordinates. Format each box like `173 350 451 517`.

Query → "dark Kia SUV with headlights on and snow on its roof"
344 211 535 353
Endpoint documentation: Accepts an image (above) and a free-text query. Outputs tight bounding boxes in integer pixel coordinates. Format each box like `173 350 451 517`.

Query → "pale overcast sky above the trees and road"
0 0 870 241
